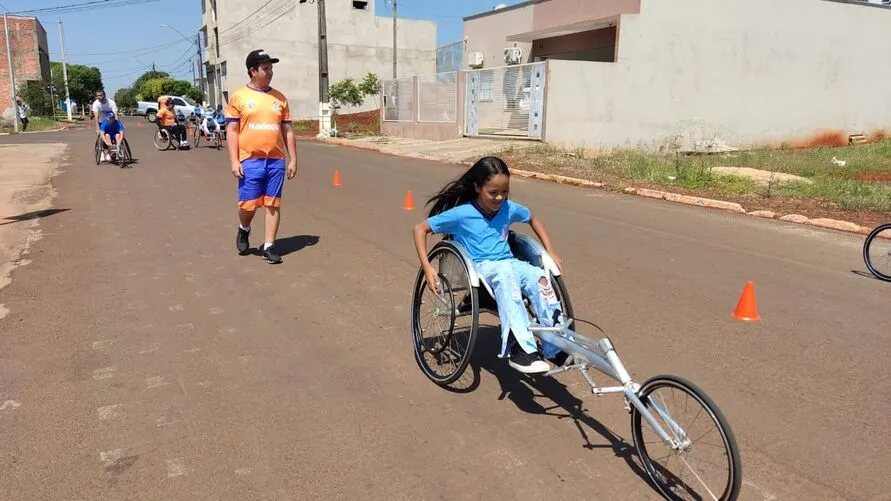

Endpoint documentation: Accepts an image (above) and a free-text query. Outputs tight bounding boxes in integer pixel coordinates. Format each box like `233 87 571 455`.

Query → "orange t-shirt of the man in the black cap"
226 86 291 161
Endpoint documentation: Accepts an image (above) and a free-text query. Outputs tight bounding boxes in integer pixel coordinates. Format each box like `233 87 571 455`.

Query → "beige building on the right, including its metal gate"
385 0 891 150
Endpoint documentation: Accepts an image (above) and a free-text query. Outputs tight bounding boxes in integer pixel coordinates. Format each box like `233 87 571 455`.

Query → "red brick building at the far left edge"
0 16 50 120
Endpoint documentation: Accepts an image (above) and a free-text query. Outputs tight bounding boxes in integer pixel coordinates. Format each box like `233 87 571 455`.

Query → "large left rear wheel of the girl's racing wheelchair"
411 242 479 386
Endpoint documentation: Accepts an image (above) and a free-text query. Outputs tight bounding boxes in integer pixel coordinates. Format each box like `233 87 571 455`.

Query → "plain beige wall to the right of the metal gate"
545 0 891 149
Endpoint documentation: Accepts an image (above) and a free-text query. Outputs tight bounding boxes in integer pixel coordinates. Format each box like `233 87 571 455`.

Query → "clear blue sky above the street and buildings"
0 0 522 96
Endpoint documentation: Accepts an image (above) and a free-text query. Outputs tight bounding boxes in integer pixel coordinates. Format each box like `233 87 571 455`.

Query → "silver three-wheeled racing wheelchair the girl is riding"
411 231 742 501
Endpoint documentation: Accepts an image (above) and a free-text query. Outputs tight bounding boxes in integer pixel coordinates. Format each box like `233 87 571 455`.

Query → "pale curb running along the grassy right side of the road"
316 137 873 235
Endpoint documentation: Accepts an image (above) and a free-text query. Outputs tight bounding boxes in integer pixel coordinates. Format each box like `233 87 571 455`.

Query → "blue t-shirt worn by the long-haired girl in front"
427 200 532 263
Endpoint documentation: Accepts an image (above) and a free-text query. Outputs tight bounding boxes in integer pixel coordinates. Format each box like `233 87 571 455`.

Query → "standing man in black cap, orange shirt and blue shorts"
226 49 297 263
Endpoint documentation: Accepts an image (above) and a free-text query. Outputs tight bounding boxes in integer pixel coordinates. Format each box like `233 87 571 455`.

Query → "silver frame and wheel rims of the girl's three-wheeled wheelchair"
411 231 742 500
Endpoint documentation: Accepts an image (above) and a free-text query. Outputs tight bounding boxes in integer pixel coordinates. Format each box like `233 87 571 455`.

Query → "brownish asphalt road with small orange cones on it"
0 121 891 500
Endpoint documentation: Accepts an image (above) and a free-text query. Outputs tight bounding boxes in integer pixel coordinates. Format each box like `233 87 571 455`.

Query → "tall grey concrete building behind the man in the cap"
200 0 436 118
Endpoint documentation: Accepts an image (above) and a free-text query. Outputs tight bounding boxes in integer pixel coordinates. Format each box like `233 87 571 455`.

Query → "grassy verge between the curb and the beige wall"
500 140 891 226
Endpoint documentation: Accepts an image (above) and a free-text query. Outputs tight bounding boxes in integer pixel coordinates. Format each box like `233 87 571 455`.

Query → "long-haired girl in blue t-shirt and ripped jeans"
414 157 567 374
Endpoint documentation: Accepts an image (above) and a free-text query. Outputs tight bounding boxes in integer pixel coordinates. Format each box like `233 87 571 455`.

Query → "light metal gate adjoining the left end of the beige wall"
465 63 545 137
